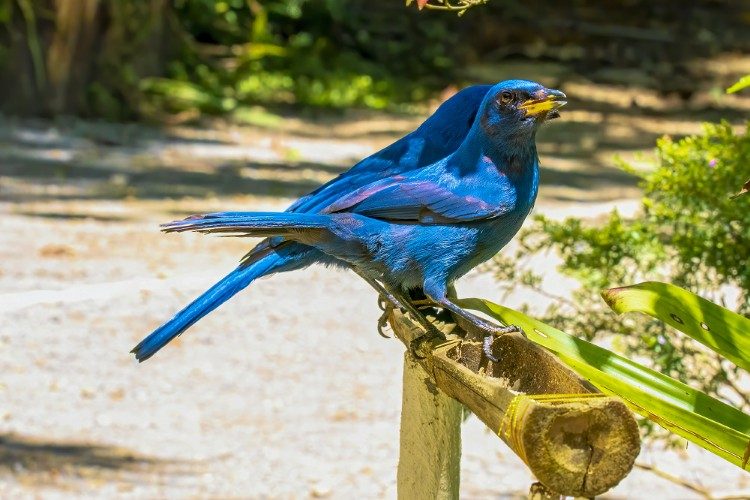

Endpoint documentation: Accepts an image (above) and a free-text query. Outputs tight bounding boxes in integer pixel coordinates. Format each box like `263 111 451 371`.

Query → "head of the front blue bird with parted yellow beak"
479 80 567 142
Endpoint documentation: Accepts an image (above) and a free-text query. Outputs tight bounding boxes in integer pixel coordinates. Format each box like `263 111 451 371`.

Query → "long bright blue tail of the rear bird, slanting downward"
130 250 305 362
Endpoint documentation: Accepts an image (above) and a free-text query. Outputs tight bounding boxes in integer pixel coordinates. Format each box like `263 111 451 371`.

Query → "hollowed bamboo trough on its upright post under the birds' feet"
389 311 640 499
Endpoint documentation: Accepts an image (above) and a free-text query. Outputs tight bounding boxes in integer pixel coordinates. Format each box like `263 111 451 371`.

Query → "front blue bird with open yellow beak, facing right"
134 80 565 360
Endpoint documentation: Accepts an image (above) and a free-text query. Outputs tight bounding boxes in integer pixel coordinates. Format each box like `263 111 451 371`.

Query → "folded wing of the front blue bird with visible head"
326 176 515 224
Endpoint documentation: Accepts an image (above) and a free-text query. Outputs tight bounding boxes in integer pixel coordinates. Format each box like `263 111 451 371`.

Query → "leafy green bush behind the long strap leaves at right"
491 123 750 438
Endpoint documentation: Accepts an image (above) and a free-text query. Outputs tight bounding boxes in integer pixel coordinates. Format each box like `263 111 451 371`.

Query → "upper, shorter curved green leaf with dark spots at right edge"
602 281 750 370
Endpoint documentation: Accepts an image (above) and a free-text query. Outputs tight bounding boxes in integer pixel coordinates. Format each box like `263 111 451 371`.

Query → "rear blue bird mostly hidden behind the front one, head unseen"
132 85 491 361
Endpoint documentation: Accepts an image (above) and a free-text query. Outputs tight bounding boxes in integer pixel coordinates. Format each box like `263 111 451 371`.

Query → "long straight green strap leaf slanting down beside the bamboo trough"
459 299 750 469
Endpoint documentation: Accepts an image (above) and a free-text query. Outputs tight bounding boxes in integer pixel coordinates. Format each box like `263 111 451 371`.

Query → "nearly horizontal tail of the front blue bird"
161 212 330 236
